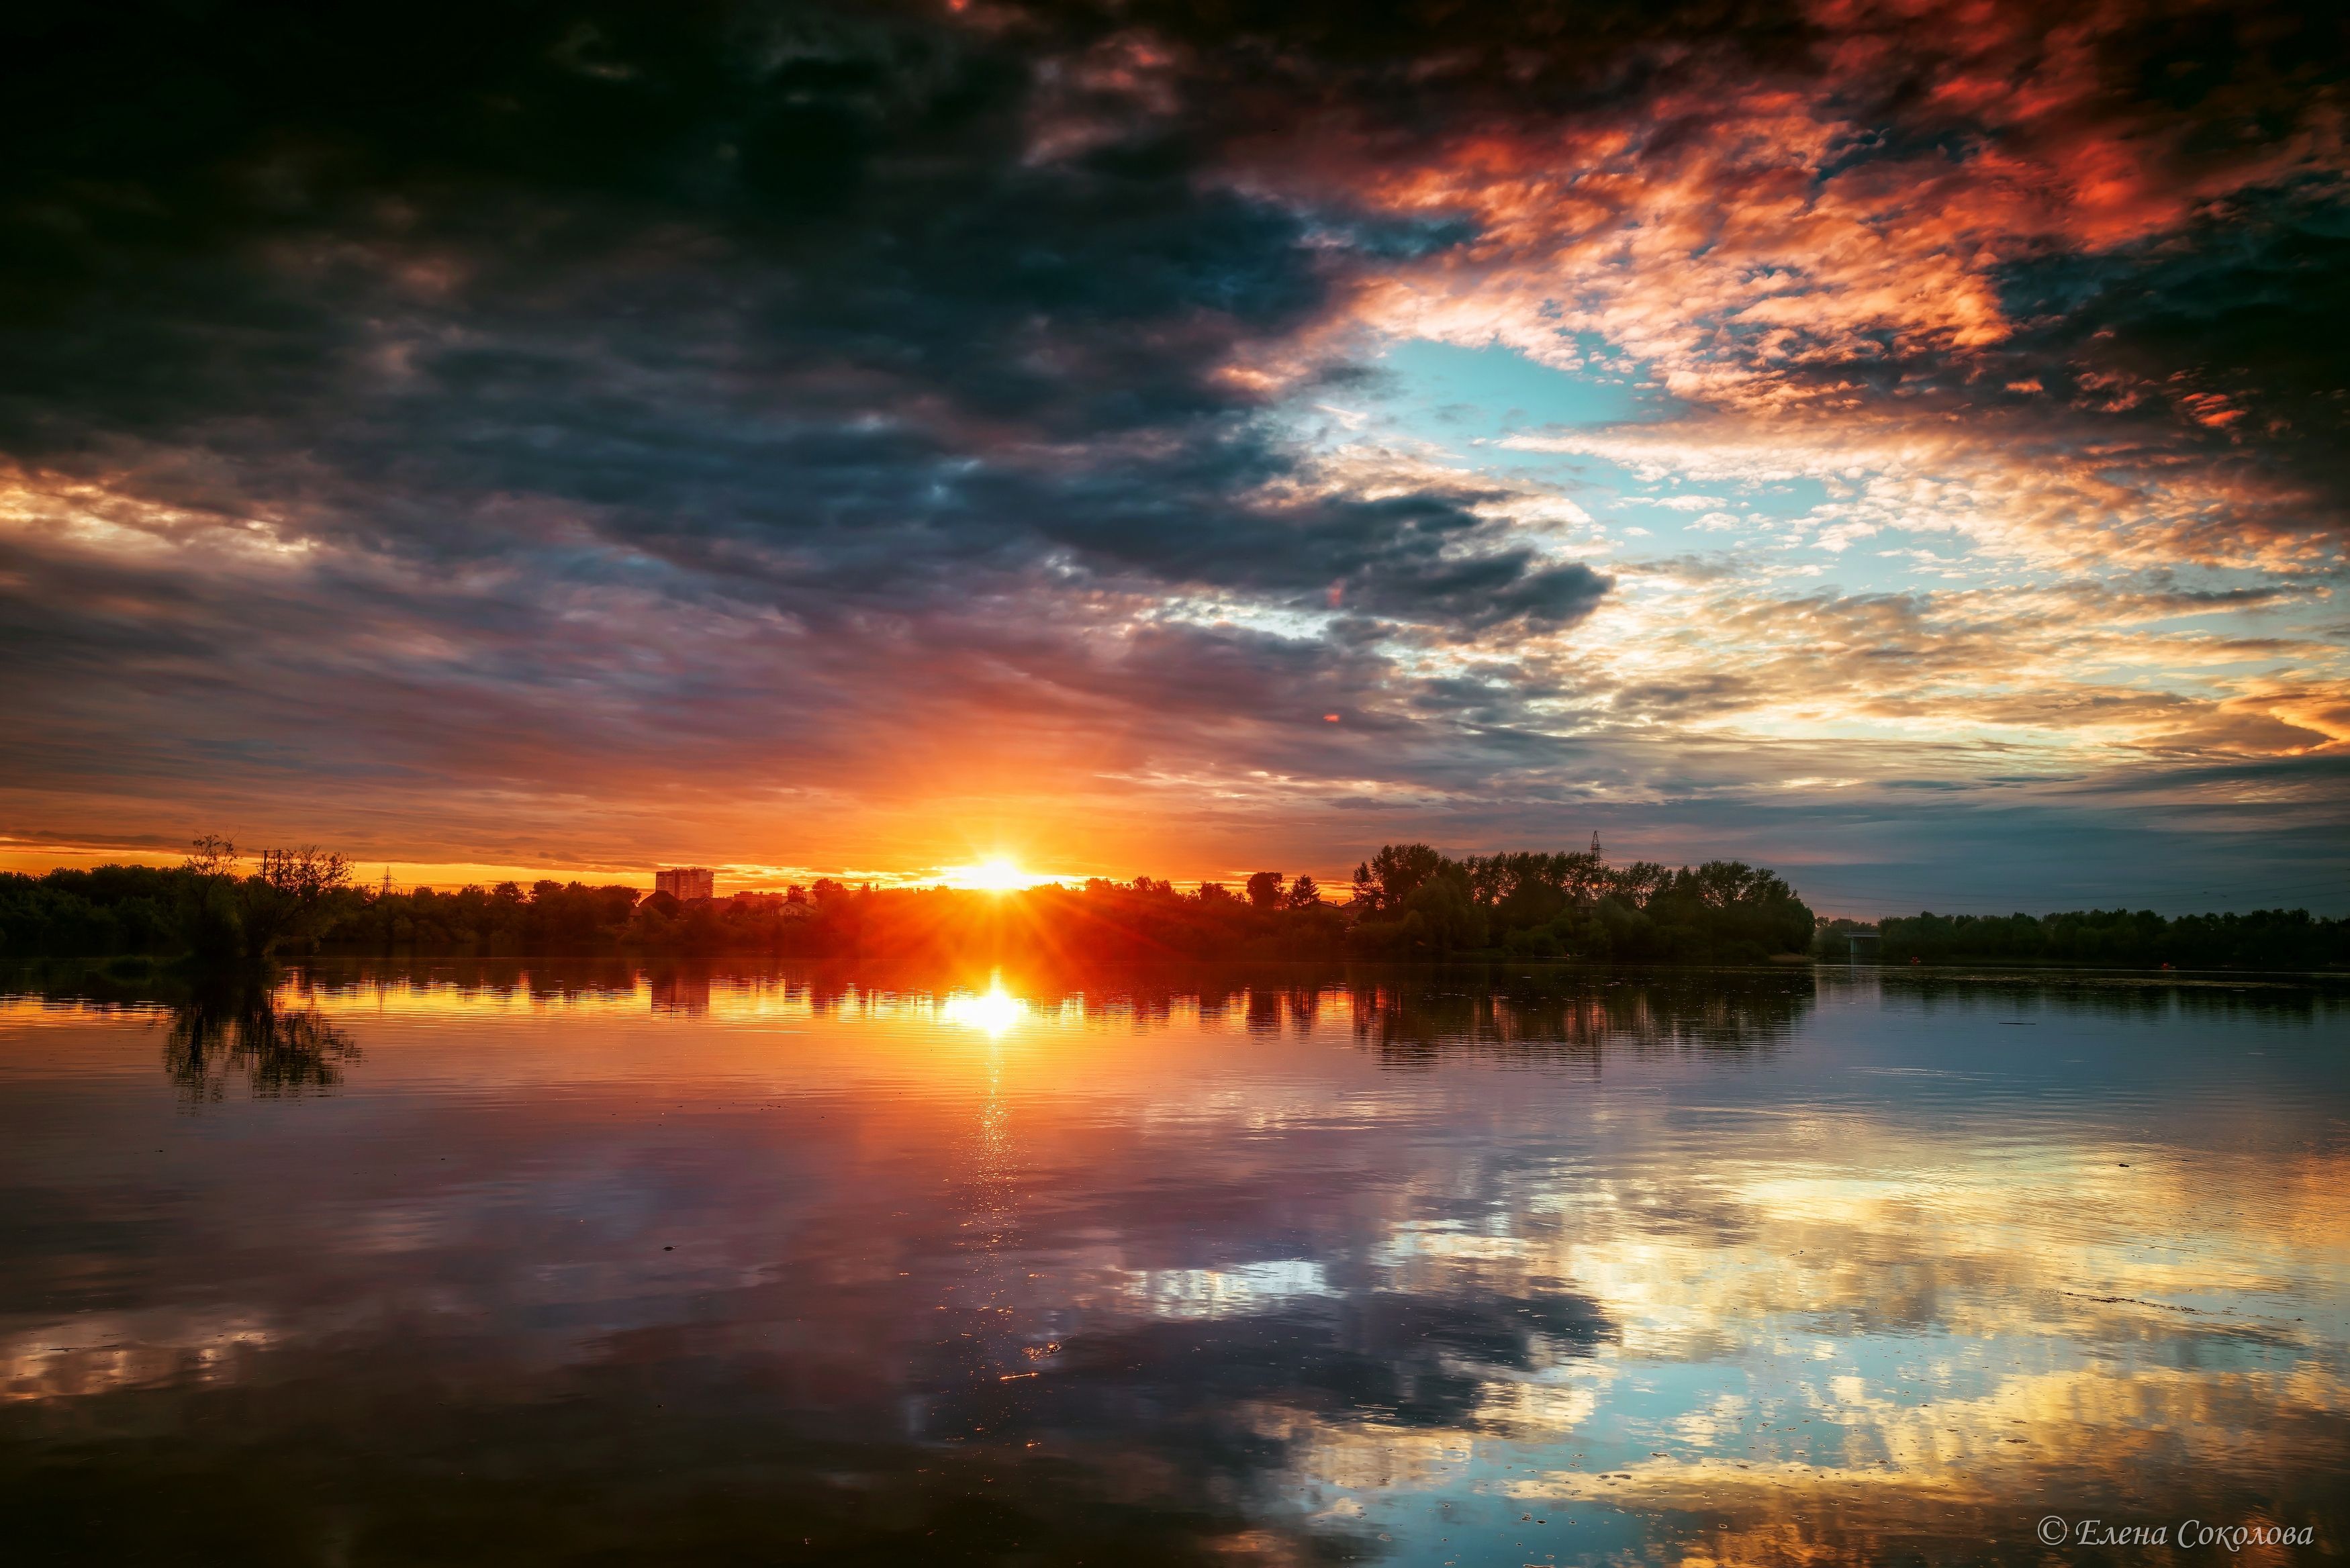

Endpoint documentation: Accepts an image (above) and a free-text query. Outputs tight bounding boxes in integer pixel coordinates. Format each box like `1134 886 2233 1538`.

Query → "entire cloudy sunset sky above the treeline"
0 0 2350 914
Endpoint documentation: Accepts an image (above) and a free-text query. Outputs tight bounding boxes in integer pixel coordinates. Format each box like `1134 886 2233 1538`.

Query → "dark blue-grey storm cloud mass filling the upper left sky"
0 7 1603 639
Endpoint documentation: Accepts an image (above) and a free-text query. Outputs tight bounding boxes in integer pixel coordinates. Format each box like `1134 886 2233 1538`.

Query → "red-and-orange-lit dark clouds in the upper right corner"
1194 0 2350 555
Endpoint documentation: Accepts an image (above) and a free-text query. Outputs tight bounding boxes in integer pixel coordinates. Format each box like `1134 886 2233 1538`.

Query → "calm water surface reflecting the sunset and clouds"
0 966 2350 1568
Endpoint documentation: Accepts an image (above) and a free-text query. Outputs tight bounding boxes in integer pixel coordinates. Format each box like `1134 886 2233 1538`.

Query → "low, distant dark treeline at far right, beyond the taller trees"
1819 910 2350 971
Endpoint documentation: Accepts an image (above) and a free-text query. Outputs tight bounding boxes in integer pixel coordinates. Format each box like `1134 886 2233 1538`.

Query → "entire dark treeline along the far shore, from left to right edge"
0 837 2350 971
